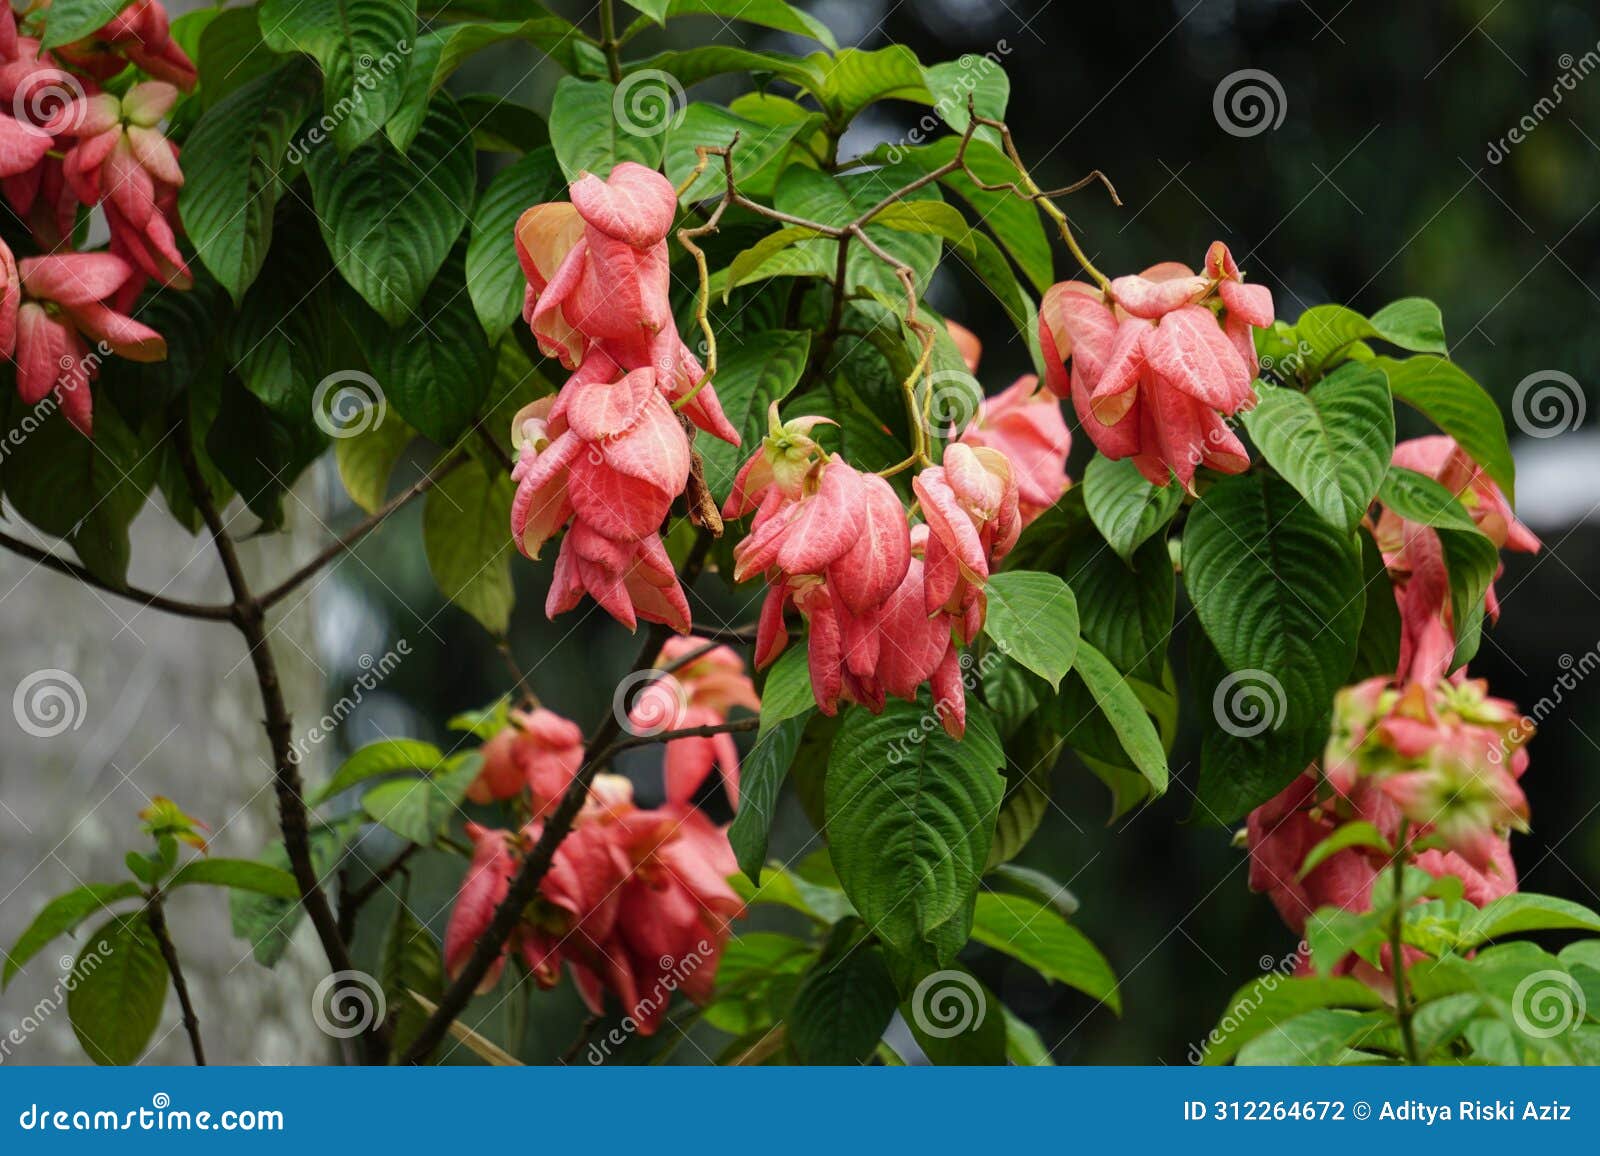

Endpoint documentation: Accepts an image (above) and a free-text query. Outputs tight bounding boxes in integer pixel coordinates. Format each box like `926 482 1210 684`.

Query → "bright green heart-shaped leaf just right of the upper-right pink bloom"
1245 363 1395 532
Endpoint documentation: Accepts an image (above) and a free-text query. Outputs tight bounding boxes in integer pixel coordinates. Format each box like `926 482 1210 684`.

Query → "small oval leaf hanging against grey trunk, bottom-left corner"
67 911 166 1066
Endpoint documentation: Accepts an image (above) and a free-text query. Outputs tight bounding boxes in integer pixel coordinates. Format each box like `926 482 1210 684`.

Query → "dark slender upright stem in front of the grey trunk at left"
176 429 389 1063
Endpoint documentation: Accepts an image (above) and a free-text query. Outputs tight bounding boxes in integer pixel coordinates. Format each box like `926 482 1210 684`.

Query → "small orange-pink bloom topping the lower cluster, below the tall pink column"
629 636 762 807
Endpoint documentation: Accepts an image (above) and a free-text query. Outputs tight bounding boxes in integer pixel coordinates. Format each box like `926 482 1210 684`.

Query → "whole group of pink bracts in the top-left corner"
0 0 195 434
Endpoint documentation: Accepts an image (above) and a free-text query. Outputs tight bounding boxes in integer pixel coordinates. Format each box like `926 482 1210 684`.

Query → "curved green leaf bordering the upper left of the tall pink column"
467 149 566 344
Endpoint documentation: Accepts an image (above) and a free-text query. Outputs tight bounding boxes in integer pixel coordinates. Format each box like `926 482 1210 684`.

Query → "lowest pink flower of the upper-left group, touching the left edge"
0 243 166 436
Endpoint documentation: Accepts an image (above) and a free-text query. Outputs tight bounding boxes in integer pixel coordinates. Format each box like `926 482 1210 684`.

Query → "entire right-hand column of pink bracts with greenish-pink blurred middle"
1248 437 1539 991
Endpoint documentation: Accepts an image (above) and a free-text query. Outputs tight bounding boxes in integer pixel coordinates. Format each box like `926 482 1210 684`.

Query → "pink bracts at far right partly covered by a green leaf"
1373 436 1541 682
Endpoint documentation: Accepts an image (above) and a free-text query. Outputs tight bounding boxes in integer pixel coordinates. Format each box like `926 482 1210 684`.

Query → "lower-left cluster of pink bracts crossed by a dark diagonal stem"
445 639 760 1036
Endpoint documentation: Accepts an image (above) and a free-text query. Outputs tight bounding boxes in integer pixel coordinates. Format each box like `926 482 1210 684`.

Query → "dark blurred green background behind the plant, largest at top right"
318 0 1600 1063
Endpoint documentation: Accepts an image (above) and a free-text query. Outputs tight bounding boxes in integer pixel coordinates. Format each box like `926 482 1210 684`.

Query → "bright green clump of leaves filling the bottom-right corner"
1205 868 1600 1065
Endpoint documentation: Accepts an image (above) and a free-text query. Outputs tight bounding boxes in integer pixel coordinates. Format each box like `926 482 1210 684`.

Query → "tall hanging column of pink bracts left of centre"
512 162 739 632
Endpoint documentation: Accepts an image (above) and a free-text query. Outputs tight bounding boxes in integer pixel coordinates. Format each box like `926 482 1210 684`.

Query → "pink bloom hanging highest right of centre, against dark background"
1038 242 1272 488
